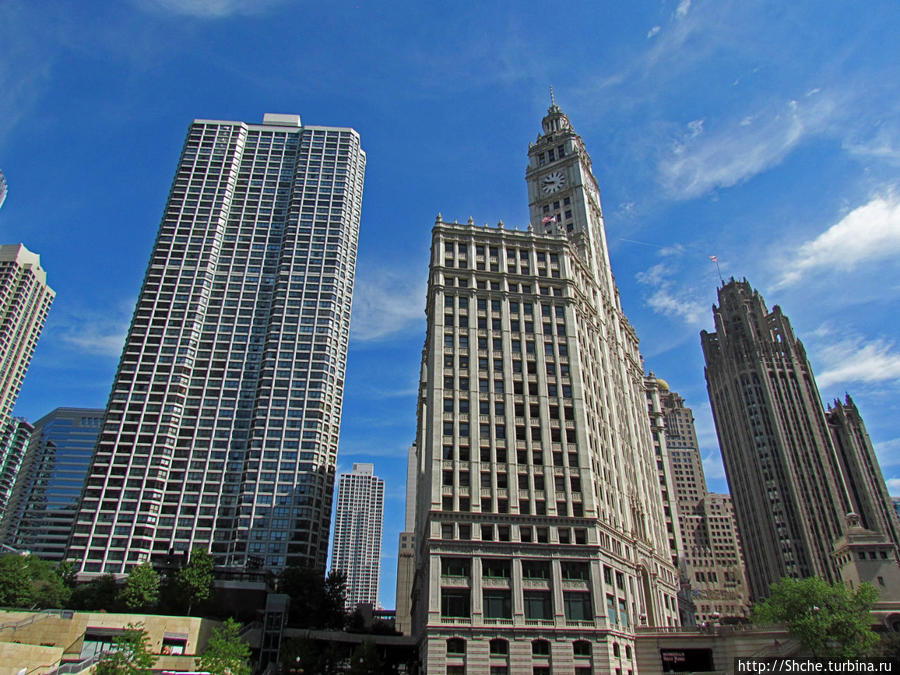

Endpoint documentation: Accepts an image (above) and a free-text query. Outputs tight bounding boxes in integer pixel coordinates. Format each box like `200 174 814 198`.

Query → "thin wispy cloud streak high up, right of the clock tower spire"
657 95 837 199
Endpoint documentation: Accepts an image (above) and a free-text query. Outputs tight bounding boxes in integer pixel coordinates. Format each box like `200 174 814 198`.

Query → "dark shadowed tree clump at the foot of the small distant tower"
278 567 347 630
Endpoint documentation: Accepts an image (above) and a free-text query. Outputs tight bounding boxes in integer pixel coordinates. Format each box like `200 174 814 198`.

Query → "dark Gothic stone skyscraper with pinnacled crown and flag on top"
701 279 897 600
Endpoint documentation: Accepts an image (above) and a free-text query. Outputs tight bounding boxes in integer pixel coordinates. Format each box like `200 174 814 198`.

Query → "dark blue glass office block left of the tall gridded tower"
0 408 105 561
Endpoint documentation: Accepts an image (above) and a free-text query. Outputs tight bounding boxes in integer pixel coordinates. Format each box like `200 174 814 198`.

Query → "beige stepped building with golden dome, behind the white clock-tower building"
646 373 750 624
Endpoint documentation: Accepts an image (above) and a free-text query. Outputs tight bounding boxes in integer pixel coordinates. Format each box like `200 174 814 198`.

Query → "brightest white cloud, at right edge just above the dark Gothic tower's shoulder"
775 192 900 290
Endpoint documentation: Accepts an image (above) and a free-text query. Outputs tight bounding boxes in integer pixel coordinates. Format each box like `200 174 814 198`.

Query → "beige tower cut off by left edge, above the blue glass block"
0 244 56 421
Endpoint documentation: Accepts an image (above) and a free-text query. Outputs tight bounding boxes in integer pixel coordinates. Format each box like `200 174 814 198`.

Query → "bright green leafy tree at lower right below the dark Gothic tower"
753 577 878 658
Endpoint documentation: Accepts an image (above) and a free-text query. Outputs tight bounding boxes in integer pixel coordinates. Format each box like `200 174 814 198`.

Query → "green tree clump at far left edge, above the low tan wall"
0 553 70 609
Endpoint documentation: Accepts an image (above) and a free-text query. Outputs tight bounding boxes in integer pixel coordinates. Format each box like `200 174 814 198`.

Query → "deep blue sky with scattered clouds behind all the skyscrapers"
0 0 900 607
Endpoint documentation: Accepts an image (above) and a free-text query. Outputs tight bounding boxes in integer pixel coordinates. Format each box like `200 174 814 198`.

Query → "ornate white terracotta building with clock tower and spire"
413 104 678 675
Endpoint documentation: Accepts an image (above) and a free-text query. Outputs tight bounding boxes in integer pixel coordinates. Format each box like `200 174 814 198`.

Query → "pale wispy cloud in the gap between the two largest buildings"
351 269 426 341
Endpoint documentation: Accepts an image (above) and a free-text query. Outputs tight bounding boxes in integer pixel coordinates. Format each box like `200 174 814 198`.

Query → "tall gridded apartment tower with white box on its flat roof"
68 114 365 574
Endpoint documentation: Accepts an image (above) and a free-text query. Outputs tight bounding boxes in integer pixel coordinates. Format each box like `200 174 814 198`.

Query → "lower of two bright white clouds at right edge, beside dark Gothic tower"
816 339 900 388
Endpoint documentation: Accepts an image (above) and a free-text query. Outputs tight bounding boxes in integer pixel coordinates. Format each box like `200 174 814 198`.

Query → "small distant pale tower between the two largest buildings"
331 464 384 610
